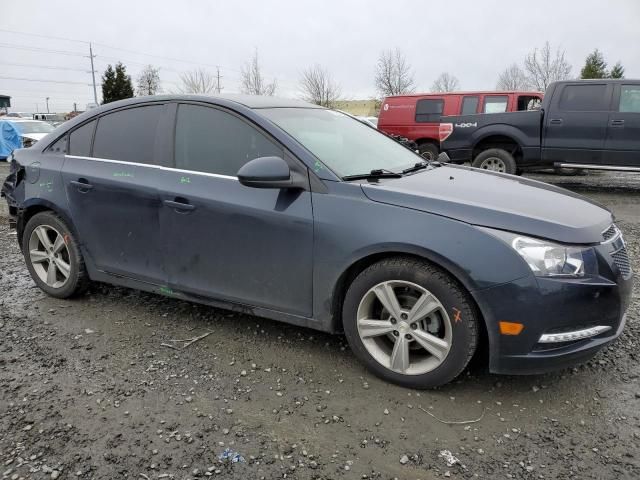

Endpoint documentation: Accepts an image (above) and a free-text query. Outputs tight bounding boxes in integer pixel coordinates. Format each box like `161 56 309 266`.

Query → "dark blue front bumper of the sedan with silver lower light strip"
474 240 632 374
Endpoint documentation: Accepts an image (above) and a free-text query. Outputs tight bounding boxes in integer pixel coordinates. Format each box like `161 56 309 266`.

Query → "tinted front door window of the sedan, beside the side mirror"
175 104 284 177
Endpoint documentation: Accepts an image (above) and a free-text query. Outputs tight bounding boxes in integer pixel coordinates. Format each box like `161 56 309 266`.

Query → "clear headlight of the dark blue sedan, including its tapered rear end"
483 228 598 278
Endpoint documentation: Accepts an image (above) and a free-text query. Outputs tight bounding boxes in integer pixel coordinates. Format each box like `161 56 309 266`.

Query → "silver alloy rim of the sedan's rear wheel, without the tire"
29 225 71 288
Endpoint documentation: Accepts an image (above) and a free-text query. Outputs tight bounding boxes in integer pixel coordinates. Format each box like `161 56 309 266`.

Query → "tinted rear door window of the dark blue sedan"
93 105 164 164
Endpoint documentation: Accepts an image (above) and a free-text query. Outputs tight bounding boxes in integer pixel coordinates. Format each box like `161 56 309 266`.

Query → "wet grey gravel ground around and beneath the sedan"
0 163 640 480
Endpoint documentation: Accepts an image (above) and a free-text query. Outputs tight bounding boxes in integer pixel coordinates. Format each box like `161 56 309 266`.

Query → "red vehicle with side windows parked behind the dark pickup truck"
378 91 542 160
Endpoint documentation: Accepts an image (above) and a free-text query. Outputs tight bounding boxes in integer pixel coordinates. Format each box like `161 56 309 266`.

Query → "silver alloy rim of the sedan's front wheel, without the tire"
356 280 452 375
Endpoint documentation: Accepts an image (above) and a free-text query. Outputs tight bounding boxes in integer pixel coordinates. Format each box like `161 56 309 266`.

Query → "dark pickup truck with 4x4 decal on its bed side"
440 79 640 174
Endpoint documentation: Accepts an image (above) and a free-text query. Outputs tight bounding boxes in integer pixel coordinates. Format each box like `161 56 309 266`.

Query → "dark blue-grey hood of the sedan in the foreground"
362 165 613 243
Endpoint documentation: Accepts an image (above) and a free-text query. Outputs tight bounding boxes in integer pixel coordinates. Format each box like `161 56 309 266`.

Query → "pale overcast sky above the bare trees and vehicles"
0 0 640 112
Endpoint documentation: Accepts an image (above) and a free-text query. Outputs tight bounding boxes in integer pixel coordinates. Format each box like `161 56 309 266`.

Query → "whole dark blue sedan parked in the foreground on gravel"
3 96 631 388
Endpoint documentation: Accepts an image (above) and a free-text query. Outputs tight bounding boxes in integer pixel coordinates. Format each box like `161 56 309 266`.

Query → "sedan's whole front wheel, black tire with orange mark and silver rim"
342 257 478 389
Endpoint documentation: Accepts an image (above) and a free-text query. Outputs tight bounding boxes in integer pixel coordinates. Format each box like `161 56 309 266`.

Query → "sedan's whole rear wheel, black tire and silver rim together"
22 212 89 298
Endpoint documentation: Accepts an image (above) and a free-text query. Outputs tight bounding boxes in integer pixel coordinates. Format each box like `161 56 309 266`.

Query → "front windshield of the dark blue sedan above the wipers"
261 108 422 177
